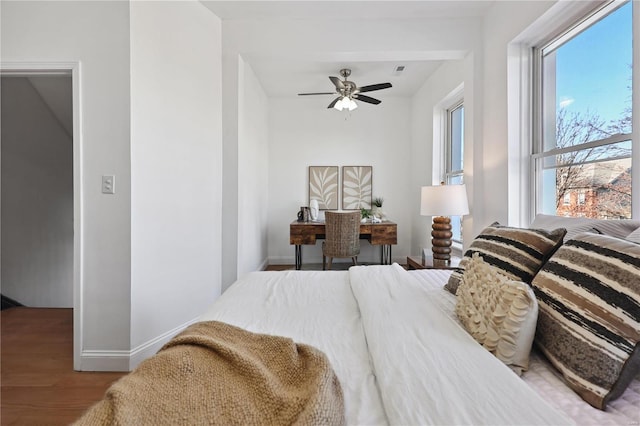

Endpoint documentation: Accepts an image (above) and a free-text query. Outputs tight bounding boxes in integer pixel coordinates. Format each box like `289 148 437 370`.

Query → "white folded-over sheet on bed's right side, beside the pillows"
349 264 573 425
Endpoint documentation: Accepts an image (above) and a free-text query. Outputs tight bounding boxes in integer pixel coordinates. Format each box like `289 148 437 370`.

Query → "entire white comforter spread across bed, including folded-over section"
202 265 571 425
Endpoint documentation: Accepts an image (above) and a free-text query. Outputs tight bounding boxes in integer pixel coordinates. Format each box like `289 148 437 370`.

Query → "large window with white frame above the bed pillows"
533 1 637 218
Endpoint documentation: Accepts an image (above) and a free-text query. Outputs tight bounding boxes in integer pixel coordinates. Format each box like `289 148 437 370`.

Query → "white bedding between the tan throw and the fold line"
200 271 388 425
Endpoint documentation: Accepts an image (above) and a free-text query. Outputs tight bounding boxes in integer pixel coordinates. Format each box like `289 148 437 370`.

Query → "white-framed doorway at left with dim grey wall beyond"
0 62 82 369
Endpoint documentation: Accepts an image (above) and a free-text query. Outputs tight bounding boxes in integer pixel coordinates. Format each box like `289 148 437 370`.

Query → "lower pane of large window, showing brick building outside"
542 158 631 219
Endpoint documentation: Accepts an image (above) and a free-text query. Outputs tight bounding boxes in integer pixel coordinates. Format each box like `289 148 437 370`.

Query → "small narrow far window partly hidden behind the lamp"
444 100 464 243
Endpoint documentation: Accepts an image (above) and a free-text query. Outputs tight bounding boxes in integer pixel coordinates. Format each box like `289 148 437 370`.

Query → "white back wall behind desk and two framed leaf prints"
269 96 416 264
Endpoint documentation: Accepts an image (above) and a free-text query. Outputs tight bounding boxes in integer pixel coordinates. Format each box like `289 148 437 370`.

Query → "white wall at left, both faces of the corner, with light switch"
1 1 222 370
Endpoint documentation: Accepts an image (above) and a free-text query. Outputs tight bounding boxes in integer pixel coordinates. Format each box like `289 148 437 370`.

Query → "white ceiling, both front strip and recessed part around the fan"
201 0 494 98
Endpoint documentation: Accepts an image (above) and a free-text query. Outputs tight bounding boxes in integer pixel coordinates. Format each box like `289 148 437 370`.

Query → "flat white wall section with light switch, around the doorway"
0 1 131 369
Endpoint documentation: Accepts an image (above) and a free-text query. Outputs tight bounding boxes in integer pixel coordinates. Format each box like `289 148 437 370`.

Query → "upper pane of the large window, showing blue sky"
542 2 633 151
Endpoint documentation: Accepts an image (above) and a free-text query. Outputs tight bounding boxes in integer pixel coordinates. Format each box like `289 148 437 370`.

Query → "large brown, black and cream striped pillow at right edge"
532 233 640 409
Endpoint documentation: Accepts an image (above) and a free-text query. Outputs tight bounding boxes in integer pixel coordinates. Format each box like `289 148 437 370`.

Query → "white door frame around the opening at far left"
0 61 84 370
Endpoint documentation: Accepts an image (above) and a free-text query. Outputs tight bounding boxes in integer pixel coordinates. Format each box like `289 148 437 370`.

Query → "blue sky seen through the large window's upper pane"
556 2 633 127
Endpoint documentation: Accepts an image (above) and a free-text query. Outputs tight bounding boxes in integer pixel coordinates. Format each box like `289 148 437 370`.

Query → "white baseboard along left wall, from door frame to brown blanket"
79 318 199 371
